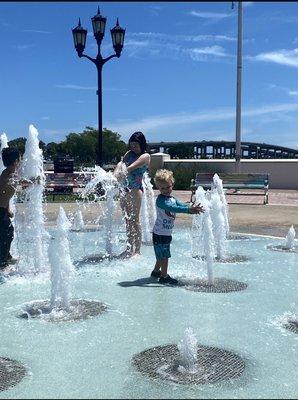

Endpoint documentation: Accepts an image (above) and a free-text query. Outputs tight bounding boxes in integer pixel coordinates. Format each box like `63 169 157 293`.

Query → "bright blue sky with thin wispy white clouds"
0 2 298 149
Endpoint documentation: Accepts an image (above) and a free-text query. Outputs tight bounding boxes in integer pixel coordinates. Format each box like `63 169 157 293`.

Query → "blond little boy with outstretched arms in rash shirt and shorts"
151 169 204 285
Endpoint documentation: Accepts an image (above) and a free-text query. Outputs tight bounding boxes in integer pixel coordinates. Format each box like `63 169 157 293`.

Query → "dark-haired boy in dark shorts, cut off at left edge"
0 147 20 270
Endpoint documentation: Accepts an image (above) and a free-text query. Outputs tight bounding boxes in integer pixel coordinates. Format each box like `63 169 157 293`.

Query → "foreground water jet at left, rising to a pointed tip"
48 207 74 310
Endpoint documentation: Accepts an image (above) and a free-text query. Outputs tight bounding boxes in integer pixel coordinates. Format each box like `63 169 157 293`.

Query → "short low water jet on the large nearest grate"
178 328 198 374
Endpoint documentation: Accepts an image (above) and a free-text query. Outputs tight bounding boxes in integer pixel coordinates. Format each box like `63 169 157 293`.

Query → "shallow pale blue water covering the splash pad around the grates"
0 229 298 399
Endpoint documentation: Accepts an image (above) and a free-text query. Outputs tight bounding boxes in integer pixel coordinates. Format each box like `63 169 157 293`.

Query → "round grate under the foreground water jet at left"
18 299 107 322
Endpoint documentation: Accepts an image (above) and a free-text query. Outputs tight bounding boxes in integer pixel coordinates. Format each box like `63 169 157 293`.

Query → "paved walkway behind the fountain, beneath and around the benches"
28 189 298 237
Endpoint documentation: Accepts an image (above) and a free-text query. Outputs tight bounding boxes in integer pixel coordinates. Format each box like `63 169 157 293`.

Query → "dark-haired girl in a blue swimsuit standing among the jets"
114 132 150 257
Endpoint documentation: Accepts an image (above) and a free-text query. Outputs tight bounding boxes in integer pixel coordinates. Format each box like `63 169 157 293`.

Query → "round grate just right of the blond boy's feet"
179 278 248 293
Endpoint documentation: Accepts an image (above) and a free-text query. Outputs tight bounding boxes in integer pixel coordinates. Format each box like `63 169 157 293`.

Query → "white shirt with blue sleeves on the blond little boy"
153 194 189 236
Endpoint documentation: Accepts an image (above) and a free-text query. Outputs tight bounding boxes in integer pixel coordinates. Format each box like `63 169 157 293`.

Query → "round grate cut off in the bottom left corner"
0 357 27 391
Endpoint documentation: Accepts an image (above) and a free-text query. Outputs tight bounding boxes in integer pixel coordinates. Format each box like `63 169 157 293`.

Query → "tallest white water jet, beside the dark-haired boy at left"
18 125 49 273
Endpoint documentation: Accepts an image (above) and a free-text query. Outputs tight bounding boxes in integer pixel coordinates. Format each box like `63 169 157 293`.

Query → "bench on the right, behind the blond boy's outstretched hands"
190 172 269 204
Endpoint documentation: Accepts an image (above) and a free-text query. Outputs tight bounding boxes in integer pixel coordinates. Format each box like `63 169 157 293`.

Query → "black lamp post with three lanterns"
72 8 125 166
